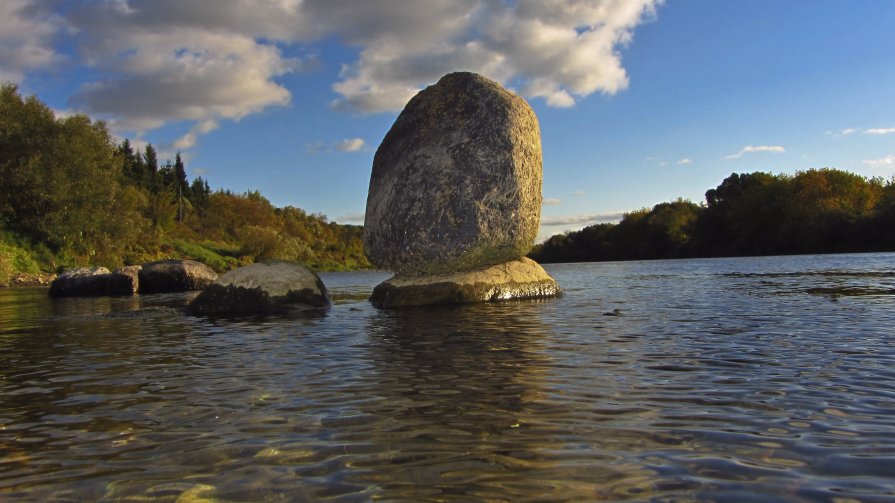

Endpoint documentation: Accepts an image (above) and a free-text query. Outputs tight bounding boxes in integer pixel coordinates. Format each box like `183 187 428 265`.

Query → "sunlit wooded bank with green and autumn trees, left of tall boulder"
0 84 370 284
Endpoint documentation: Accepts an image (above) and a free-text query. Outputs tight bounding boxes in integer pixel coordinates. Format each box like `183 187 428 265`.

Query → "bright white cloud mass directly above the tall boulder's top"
333 0 661 113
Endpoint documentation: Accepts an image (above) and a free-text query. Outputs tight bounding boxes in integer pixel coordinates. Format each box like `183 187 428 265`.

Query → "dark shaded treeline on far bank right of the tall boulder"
529 168 895 262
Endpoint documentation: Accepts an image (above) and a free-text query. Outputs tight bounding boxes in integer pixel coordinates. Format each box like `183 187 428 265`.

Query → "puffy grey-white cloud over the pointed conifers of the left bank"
71 28 298 133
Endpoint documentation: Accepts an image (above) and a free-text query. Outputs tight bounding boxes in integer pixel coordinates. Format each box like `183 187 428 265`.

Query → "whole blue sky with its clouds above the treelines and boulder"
0 0 895 239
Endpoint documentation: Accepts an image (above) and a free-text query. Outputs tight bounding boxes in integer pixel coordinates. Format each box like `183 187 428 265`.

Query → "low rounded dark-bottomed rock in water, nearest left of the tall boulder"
187 262 330 315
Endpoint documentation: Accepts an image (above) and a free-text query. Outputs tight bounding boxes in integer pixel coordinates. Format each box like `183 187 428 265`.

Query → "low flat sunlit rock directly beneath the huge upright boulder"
370 258 561 307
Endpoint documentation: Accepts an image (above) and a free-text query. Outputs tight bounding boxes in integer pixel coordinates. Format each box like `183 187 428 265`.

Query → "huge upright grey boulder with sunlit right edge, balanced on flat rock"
364 73 542 275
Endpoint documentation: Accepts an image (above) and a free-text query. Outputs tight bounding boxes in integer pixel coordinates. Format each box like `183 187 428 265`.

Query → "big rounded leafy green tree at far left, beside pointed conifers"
0 86 151 263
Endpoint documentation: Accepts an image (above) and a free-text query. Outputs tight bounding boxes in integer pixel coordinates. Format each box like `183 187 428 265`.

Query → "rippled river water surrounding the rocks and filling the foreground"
0 254 895 502
